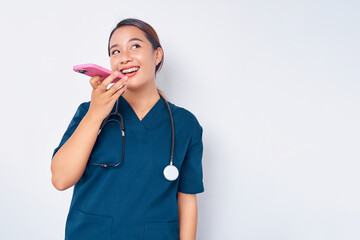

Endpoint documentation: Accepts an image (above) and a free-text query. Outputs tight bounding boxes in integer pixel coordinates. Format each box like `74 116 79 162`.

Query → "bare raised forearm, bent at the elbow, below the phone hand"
51 114 101 190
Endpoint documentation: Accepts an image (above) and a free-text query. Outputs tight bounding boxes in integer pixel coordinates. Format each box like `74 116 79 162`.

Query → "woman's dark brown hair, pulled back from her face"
108 18 165 97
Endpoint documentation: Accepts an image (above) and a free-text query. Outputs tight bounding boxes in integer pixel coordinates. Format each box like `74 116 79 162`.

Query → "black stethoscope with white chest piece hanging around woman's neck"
89 94 179 181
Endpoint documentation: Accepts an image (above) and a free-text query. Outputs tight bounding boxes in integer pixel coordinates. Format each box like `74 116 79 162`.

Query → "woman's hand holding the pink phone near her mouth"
87 71 127 121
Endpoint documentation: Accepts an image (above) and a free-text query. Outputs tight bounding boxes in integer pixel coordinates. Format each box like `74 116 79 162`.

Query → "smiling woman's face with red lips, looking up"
110 26 162 90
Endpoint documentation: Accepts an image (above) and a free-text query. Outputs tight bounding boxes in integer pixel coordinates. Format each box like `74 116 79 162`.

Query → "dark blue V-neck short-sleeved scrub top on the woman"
53 96 204 240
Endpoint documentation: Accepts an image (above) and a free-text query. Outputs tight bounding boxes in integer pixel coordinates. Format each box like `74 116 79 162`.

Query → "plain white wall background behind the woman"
0 0 360 240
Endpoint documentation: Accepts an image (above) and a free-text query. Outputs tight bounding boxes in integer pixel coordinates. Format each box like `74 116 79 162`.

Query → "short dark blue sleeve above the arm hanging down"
178 117 204 194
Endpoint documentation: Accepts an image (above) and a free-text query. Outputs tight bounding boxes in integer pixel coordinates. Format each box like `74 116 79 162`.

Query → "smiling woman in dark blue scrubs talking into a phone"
51 19 204 240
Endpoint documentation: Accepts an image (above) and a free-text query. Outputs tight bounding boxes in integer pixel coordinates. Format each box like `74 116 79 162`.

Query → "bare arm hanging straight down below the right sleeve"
178 192 197 240
